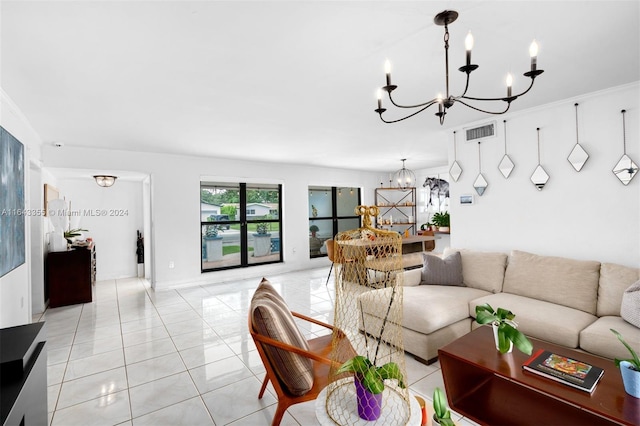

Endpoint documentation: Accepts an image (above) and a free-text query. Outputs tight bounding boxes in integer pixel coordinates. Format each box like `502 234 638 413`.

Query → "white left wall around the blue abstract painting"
0 90 41 328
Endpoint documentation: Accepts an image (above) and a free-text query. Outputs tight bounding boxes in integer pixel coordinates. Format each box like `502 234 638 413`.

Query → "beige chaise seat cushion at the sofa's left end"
402 285 490 334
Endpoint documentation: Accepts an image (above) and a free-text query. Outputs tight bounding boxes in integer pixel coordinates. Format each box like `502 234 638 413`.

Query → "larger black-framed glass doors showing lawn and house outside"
200 182 282 272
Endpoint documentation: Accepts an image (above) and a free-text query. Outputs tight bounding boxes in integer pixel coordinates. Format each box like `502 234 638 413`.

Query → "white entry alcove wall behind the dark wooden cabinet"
58 179 144 281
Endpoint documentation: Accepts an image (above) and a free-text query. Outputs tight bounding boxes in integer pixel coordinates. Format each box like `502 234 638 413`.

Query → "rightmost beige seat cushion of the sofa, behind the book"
580 316 640 359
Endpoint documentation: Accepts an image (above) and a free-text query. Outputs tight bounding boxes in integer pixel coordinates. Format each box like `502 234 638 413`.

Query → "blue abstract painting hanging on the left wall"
0 127 25 277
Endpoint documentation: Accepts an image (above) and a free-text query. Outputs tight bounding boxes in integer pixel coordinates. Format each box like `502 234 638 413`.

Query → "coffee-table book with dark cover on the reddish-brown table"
522 349 604 393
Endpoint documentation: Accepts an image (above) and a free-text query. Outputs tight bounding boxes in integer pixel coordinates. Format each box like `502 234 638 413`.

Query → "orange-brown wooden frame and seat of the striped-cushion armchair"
249 279 356 426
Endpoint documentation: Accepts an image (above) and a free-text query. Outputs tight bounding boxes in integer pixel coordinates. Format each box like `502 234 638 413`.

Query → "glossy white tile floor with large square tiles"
33 268 472 426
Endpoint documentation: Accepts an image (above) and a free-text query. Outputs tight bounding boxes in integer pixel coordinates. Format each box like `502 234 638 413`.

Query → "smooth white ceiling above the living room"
0 0 640 171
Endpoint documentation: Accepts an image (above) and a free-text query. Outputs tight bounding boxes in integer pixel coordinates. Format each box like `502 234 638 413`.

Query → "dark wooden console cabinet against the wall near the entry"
46 244 96 308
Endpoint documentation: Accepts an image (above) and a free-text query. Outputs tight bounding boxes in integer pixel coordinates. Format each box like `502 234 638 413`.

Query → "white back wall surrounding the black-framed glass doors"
43 146 384 288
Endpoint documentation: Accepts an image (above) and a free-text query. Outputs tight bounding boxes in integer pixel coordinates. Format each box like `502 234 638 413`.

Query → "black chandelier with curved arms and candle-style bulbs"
375 10 544 124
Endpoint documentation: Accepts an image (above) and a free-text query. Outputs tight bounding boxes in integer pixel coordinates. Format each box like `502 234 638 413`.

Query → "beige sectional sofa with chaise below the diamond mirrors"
372 249 640 362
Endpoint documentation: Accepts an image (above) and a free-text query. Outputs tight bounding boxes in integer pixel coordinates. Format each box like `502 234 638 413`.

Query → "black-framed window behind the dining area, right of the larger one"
308 186 360 257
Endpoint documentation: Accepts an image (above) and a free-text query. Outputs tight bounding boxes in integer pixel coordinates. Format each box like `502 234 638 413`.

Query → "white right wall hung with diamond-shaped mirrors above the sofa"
448 83 640 267
